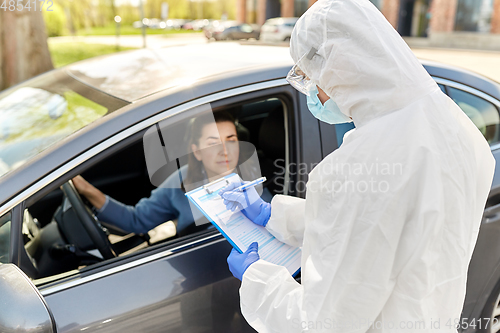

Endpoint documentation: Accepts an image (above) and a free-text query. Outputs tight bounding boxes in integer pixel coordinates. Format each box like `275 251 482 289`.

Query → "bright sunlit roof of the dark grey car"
66 43 293 102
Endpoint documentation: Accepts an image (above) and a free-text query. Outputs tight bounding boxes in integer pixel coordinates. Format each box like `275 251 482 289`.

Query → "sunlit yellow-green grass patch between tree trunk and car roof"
49 42 137 68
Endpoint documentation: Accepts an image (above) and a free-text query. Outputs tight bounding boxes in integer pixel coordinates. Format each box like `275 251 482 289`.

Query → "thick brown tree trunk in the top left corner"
0 0 54 90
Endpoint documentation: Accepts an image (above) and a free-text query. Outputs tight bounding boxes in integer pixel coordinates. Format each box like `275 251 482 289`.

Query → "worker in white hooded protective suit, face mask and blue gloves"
220 0 495 333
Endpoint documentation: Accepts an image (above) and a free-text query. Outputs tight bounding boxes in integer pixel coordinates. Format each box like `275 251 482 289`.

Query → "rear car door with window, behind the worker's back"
435 78 500 332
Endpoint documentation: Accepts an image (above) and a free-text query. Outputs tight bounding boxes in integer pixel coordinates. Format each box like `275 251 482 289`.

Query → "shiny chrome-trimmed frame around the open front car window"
4 79 297 295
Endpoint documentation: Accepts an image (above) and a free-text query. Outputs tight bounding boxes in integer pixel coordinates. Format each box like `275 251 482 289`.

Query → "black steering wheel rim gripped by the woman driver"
61 180 116 259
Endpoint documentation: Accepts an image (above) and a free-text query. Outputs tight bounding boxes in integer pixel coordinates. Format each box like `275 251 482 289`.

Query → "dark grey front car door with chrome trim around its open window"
7 80 321 332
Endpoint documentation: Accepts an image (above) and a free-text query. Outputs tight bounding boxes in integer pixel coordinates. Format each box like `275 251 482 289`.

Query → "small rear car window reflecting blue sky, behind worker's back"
448 87 500 145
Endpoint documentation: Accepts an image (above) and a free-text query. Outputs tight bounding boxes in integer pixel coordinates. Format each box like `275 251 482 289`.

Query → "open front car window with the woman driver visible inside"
23 94 288 284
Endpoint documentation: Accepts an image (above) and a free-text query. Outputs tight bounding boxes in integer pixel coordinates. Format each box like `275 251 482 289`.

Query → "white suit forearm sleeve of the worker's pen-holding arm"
266 195 306 247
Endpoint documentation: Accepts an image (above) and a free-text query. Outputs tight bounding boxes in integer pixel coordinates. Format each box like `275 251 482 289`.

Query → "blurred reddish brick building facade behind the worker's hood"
236 0 500 37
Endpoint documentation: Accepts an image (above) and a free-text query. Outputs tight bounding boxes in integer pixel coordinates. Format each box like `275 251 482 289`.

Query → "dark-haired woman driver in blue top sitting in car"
73 112 254 235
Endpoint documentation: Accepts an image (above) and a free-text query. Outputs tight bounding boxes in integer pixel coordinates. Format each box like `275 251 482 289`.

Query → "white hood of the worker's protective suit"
290 0 436 127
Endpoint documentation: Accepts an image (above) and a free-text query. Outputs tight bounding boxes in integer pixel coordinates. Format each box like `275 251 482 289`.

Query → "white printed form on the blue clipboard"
186 173 302 275
